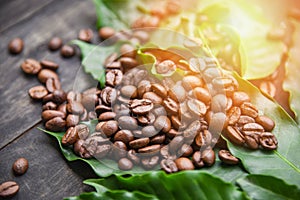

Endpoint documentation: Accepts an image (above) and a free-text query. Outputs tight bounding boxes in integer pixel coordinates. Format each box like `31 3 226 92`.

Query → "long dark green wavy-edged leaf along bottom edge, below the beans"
85 170 248 200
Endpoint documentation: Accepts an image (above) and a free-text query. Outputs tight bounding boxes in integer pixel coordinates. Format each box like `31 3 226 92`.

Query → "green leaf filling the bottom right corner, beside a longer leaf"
237 175 300 200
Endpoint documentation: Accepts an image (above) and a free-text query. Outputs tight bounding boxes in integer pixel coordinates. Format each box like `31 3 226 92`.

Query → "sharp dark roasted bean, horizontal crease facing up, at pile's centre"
129 99 153 115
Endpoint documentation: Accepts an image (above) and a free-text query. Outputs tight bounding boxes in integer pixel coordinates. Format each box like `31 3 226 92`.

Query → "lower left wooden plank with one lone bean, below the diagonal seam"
0 124 96 200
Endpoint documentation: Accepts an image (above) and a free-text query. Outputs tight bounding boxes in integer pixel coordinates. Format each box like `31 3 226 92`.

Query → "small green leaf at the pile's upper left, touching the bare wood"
71 40 129 87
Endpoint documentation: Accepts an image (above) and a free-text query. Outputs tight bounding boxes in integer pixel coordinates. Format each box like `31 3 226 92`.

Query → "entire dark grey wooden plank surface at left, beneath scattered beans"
0 0 97 200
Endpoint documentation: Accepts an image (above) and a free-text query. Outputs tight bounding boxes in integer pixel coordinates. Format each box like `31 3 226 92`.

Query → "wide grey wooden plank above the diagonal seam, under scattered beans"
0 0 96 149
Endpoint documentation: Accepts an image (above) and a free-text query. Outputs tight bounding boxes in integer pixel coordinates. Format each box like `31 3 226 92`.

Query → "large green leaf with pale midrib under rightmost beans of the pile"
228 74 300 186
